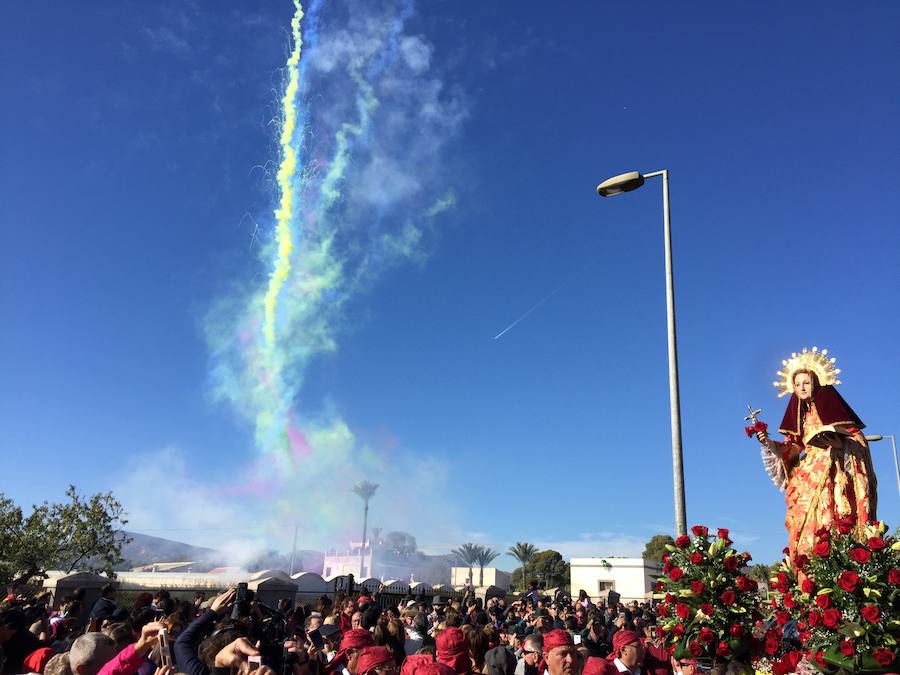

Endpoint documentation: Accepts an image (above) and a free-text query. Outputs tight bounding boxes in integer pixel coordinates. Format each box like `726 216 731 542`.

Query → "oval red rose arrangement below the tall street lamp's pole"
654 525 760 662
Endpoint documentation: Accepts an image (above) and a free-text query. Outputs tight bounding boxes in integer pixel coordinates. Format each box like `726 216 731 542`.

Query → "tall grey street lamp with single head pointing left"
597 169 687 534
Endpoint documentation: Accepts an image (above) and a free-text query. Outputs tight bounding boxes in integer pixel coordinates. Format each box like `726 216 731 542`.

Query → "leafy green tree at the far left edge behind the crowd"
0 485 131 585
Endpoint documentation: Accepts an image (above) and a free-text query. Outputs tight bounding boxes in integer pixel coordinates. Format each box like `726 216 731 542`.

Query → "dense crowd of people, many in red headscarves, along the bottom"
0 583 696 675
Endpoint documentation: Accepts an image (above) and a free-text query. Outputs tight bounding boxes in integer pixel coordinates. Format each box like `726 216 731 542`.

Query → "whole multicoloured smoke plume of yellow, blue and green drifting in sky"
206 1 465 543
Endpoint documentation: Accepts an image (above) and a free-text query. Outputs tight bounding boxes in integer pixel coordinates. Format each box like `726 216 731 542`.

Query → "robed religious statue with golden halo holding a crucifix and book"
746 347 877 562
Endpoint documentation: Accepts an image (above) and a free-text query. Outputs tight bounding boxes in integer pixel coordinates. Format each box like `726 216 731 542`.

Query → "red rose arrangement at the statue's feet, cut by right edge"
766 518 900 675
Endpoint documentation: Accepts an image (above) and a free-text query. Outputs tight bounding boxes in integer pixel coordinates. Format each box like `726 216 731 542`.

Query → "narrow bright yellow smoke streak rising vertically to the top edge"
263 0 303 349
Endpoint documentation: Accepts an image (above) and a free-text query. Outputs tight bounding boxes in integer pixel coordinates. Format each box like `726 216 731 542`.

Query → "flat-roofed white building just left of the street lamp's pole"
569 556 662 602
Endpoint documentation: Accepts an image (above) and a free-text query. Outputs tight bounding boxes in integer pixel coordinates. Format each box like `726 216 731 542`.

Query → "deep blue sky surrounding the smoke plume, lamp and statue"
0 1 900 566
